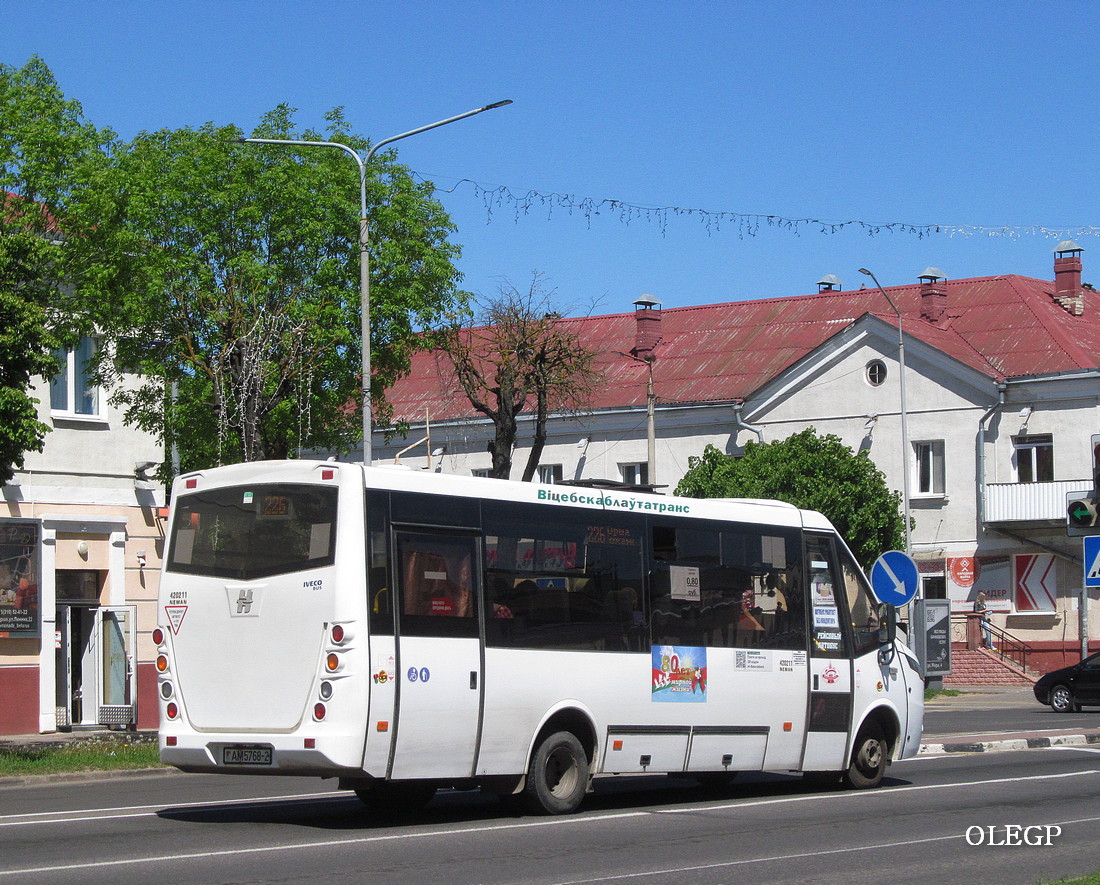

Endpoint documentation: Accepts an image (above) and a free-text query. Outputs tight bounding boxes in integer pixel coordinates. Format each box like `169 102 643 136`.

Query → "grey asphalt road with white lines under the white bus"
0 743 1100 885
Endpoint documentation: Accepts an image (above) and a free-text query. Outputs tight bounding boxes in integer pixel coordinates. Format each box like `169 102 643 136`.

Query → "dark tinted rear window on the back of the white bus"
167 484 338 580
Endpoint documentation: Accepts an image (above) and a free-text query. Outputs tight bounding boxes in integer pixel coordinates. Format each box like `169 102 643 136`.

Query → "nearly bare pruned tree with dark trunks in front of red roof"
439 274 602 482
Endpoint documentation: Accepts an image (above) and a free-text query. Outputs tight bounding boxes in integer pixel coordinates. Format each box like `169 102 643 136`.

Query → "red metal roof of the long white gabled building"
387 275 1100 421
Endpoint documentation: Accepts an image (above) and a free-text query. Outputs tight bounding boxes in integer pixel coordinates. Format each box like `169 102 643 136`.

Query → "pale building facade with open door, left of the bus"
0 339 165 734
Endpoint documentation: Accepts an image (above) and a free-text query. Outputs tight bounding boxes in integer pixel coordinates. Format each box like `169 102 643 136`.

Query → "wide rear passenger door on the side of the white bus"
389 529 483 779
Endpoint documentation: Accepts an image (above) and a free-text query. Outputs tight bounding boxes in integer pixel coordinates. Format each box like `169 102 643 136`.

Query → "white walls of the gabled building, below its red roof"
374 323 1100 661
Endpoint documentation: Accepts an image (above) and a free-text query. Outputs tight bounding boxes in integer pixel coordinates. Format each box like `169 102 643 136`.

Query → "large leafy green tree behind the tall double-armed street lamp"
80 106 463 469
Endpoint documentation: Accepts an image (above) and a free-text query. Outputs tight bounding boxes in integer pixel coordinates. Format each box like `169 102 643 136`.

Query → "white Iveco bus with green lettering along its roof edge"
153 461 924 814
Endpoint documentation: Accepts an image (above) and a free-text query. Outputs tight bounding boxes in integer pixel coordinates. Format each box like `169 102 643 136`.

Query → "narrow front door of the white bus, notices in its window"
802 534 851 772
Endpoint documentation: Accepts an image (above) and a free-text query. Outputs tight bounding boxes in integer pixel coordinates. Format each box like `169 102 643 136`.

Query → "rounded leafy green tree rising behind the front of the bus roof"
677 428 905 567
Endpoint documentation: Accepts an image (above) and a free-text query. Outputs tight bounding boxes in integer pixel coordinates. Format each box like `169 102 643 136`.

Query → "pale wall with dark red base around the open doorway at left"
0 358 164 733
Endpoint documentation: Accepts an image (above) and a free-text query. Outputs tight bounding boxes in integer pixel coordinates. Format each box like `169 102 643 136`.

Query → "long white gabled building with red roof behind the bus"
374 241 1100 666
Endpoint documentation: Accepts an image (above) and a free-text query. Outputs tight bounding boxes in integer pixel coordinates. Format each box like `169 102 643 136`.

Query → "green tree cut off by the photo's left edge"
0 57 113 482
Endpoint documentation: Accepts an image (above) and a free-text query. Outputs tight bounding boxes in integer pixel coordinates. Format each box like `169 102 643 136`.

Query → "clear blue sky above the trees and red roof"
0 0 1100 312
